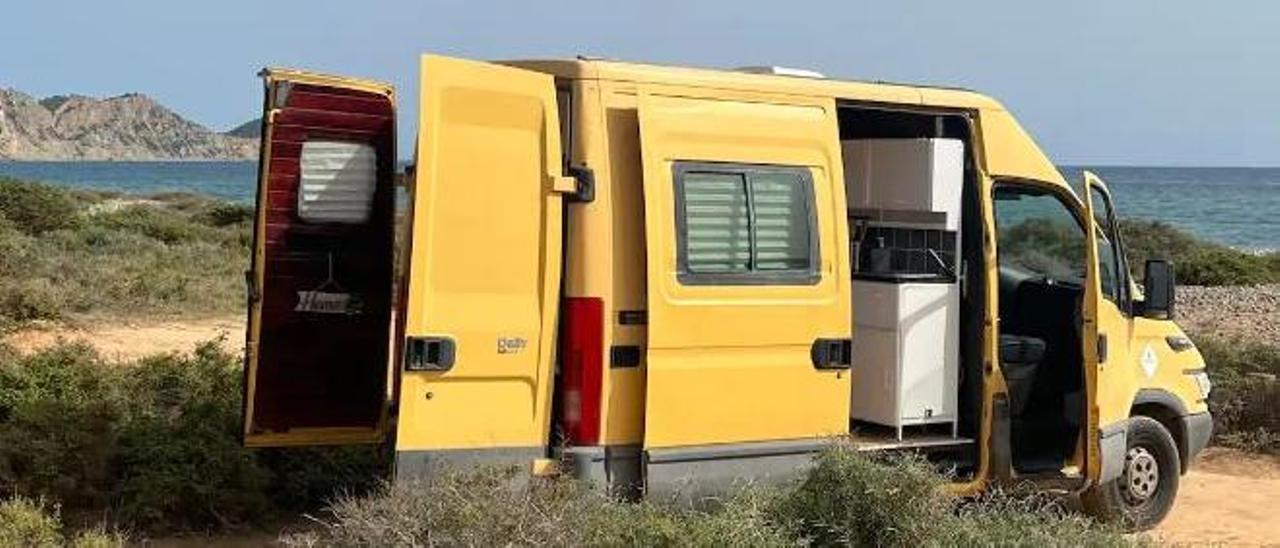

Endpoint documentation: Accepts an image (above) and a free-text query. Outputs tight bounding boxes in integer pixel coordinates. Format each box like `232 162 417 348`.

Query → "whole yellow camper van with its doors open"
243 55 1212 528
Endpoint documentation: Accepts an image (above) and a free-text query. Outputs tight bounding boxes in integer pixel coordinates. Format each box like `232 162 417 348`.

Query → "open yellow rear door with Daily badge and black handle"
396 55 573 478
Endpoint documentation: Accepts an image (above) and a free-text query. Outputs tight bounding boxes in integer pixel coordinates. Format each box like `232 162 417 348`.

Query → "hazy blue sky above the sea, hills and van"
0 0 1280 166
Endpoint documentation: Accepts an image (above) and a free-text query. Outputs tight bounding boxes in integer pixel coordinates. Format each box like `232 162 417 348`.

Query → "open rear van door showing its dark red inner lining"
243 69 396 446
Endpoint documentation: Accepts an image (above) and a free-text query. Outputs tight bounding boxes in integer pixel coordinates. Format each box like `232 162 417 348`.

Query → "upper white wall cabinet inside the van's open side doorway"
841 138 964 230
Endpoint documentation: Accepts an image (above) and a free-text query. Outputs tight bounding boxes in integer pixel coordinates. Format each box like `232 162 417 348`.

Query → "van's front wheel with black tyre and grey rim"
1080 416 1181 531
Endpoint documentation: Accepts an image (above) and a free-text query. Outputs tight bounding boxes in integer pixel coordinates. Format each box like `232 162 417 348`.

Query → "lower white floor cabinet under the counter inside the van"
850 279 960 438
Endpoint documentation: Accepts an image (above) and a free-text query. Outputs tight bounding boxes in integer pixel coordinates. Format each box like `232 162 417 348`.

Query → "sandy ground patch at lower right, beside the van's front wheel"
1151 448 1280 547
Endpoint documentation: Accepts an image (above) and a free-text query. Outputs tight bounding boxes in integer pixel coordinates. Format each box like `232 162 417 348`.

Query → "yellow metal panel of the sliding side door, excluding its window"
639 86 852 449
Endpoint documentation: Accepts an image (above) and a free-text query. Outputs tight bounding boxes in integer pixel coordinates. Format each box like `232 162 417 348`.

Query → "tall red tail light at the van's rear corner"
559 297 604 446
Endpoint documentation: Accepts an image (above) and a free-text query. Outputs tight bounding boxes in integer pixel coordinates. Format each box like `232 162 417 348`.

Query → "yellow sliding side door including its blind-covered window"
639 87 852 453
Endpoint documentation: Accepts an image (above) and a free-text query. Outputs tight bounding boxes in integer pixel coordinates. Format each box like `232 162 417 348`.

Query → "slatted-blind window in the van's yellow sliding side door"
675 163 818 286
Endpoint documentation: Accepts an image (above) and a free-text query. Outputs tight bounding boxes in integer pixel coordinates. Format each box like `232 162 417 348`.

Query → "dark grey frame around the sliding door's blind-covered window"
672 160 822 286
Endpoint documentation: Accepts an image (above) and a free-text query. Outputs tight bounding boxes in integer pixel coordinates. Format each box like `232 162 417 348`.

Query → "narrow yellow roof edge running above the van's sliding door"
502 58 1004 110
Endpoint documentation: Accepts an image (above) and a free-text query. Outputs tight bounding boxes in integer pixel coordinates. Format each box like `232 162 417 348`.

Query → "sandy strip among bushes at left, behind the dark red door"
5 314 244 360
